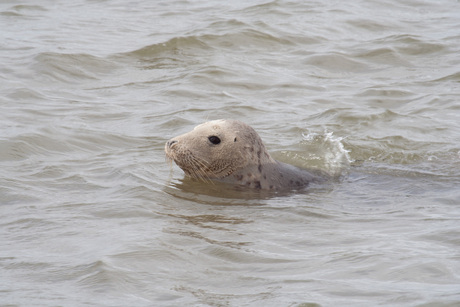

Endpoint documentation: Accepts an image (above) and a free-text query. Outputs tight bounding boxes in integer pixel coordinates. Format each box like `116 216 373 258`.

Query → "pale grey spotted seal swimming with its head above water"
165 119 321 191
